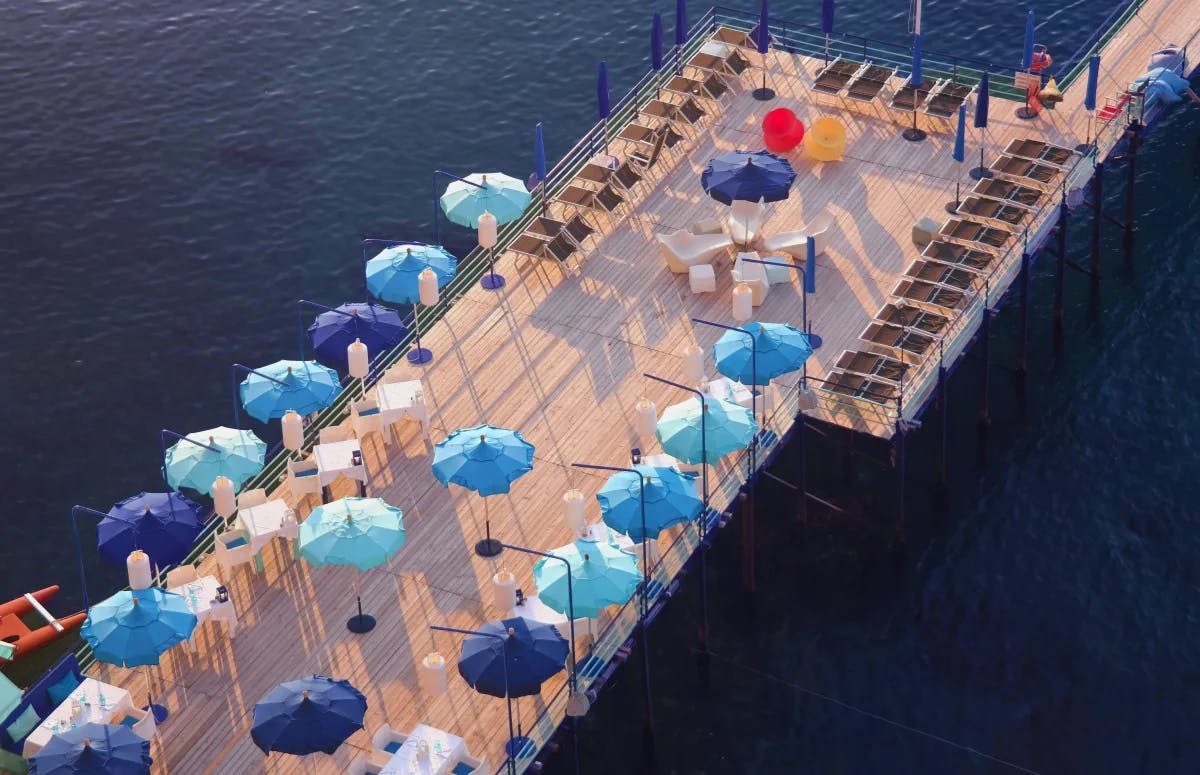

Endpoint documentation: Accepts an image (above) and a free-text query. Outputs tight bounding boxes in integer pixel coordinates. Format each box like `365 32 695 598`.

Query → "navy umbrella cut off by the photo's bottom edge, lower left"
29 722 154 775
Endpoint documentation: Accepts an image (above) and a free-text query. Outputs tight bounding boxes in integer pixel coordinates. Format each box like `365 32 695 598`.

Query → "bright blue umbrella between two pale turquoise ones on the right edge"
596 465 704 541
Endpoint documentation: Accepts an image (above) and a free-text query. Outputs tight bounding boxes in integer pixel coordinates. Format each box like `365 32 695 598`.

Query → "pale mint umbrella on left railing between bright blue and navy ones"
163 426 266 495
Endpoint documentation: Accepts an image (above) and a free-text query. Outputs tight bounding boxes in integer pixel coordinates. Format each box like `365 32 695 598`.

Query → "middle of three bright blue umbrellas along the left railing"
238 360 342 422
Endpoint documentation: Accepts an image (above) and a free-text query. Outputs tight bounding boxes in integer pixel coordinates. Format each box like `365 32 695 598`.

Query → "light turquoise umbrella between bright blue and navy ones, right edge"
533 540 642 619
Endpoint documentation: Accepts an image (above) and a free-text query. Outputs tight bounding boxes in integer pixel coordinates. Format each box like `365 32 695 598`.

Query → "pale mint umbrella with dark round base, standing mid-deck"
300 498 404 632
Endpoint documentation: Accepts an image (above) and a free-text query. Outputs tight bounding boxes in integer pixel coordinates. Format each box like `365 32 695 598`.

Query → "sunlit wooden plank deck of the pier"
72 0 1200 775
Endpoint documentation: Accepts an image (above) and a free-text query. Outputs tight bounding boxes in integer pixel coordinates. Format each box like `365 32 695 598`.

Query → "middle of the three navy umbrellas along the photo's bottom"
250 675 367 756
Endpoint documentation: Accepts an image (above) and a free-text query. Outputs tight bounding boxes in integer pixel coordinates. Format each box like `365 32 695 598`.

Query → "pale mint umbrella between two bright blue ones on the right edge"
658 396 758 464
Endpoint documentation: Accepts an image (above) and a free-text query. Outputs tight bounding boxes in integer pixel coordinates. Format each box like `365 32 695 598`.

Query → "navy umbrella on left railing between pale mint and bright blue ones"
97 492 205 567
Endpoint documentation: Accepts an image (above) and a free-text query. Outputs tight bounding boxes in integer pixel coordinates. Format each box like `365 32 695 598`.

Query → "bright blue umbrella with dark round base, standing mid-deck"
433 425 534 557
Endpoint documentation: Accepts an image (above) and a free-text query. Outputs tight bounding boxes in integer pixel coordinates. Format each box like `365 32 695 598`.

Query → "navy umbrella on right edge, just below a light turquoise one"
458 617 569 697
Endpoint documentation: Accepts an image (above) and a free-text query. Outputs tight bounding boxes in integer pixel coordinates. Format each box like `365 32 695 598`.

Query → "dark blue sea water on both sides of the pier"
0 0 1200 773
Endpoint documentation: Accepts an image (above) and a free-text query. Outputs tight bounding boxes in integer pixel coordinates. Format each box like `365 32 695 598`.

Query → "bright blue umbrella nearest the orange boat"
80 587 196 667
